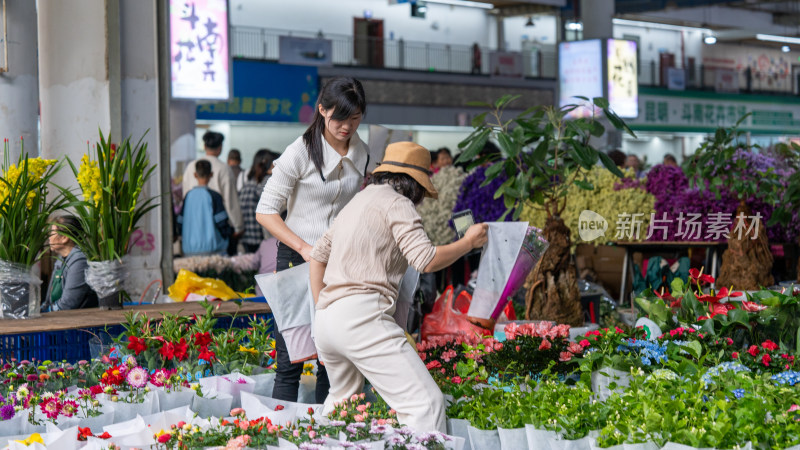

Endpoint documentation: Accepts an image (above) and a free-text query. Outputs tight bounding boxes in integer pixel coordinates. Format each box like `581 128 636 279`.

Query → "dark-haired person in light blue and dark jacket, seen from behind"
175 160 233 255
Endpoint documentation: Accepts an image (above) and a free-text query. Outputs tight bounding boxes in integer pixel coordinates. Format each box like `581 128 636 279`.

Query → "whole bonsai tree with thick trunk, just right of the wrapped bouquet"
458 95 634 326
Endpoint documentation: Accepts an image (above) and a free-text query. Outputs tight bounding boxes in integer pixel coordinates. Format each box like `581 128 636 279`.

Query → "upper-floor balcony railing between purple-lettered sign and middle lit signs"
231 27 555 78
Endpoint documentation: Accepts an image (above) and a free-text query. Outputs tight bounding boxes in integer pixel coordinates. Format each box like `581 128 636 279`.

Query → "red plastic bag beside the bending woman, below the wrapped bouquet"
421 286 492 340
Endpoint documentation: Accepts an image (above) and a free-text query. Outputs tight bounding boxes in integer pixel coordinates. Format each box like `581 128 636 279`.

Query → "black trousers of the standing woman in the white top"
272 243 331 403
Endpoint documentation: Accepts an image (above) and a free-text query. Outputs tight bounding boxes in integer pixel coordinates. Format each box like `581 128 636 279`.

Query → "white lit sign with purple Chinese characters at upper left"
169 0 230 100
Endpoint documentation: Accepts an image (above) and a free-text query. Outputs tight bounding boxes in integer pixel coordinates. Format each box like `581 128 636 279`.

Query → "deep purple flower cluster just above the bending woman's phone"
453 167 507 223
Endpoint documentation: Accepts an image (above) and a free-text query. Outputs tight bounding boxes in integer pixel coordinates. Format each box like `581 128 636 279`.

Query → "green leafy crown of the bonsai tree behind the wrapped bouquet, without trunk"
458 95 635 220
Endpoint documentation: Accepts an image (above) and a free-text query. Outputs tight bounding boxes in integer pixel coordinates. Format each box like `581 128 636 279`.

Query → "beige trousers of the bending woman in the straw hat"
314 294 446 433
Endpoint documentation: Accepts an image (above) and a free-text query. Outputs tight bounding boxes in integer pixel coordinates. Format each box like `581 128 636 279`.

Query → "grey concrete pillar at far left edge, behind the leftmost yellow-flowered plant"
0 0 39 162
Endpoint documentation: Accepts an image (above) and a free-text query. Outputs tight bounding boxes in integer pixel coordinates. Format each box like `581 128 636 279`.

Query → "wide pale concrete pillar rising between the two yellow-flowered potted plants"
38 0 122 187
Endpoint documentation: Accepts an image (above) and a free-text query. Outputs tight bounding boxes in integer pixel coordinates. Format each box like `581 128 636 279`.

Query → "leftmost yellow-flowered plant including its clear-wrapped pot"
0 139 67 319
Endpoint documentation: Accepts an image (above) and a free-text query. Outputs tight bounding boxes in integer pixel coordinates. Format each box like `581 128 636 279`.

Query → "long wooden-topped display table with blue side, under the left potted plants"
0 301 272 362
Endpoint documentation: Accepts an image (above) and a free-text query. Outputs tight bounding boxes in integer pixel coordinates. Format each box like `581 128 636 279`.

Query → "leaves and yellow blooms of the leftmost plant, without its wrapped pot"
0 139 67 267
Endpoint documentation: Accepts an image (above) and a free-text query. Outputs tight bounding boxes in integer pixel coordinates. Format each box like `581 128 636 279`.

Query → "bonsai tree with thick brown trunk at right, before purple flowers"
685 115 782 290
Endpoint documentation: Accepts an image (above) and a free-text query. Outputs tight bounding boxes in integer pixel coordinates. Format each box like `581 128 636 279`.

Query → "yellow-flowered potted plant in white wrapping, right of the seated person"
62 131 158 309
